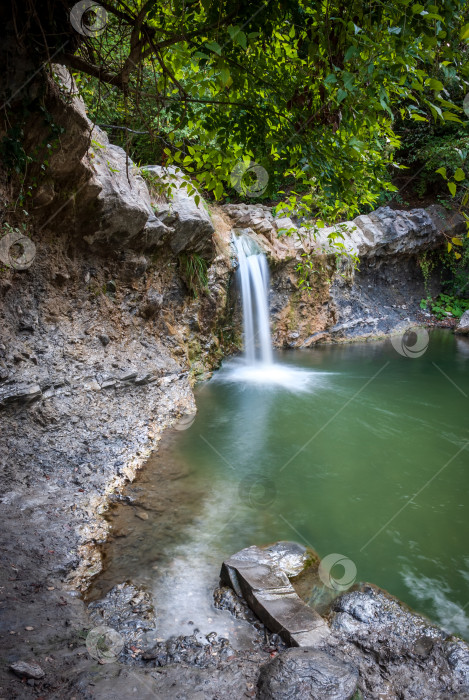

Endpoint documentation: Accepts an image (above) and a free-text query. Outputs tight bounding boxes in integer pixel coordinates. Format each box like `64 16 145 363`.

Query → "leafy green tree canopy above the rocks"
3 0 469 220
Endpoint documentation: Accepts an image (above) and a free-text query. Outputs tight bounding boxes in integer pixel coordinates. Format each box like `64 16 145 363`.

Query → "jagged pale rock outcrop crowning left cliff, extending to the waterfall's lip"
34 66 215 259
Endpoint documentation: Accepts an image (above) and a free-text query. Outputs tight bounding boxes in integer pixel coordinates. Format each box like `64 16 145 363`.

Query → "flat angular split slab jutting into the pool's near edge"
220 542 330 647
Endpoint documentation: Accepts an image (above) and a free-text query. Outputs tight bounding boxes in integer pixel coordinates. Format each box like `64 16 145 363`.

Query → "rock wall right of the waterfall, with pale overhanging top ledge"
223 204 465 348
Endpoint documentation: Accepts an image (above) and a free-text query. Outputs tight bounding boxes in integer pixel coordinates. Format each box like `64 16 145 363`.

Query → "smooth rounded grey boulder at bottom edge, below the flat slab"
257 648 358 700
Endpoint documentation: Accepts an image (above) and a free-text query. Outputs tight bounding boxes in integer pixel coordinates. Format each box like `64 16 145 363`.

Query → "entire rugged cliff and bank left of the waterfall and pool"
0 68 236 697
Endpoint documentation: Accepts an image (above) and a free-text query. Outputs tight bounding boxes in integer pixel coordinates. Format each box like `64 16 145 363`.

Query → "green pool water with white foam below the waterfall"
93 331 469 638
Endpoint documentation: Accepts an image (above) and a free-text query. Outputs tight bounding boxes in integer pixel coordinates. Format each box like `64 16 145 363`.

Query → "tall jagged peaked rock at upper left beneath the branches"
40 66 170 250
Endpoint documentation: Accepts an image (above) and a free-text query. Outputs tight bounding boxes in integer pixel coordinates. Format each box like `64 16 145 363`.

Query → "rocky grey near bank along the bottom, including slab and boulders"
54 542 469 700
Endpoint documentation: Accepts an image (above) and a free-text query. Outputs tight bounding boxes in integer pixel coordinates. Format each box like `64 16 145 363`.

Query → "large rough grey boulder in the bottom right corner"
329 584 469 700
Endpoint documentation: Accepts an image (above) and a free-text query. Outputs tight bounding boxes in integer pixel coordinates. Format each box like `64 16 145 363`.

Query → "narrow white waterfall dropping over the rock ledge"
234 236 273 365
